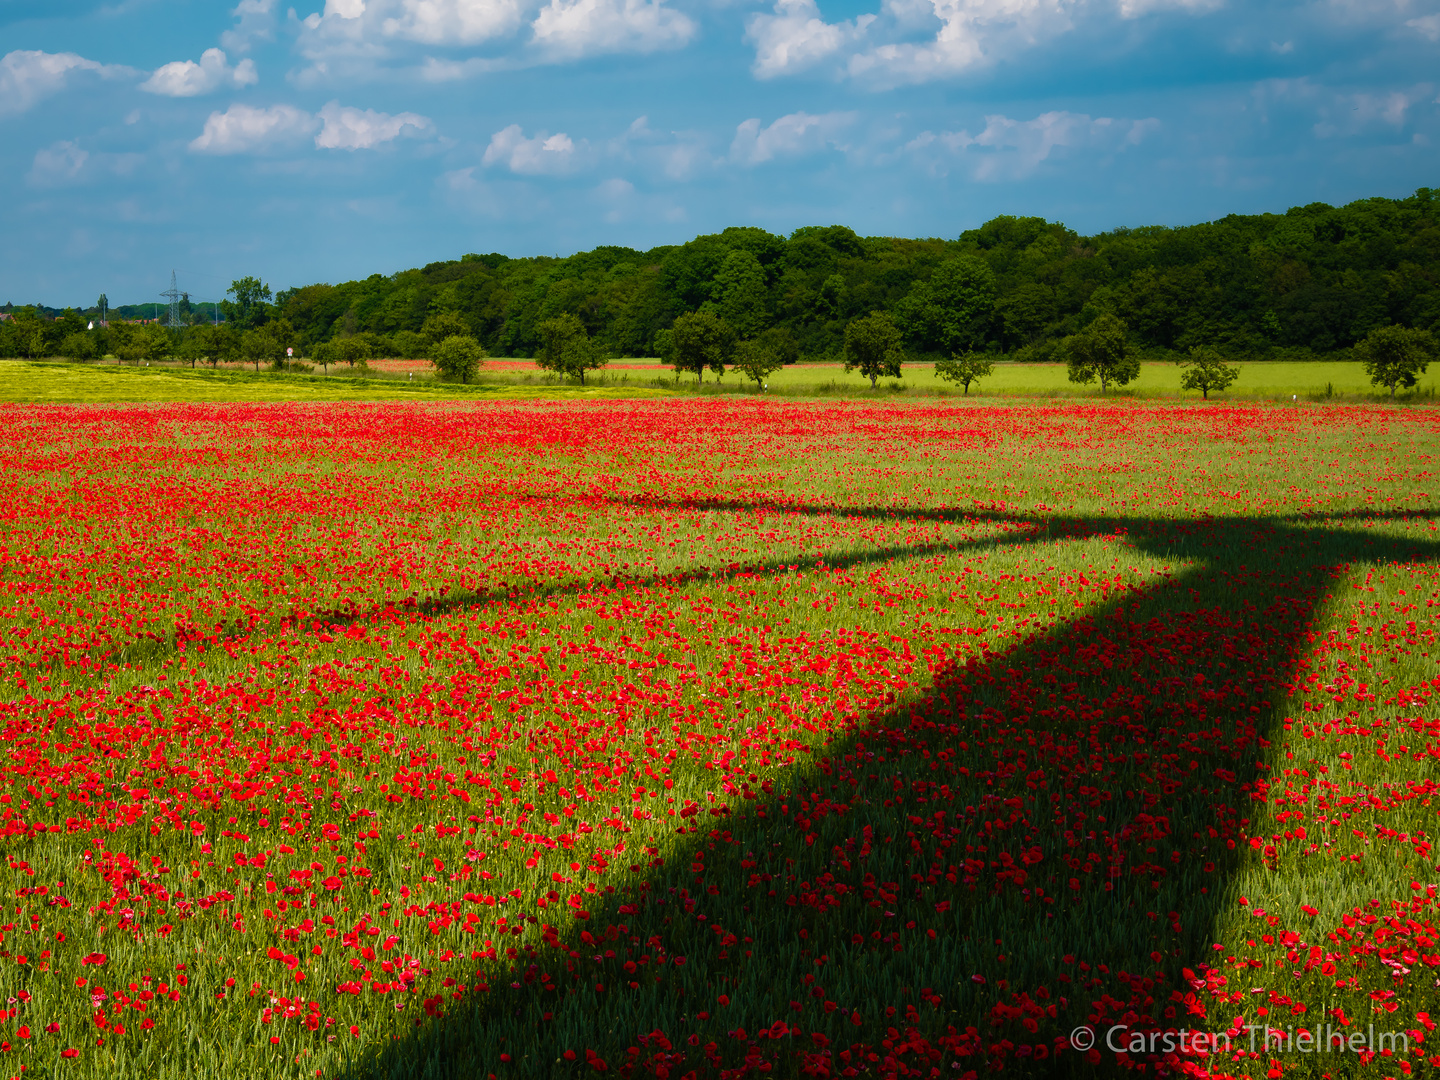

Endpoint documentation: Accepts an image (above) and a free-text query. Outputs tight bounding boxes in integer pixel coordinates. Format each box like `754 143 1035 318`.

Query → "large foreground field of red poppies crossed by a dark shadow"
0 400 1440 1080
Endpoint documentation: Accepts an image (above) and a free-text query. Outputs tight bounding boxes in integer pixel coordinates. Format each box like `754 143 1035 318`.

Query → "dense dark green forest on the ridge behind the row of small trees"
0 189 1440 360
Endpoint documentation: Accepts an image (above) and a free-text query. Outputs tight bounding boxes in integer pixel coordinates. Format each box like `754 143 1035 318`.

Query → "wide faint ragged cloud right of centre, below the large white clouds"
907 111 1159 181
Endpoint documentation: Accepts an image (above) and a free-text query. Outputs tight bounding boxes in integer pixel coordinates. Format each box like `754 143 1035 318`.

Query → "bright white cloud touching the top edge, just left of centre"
531 0 698 58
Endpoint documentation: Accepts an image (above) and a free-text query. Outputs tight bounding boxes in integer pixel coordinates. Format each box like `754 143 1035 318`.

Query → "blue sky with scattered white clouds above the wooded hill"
0 0 1440 305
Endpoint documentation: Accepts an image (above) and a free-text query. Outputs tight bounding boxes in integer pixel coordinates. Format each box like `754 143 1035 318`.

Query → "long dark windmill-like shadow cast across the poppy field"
318 504 1440 1079
